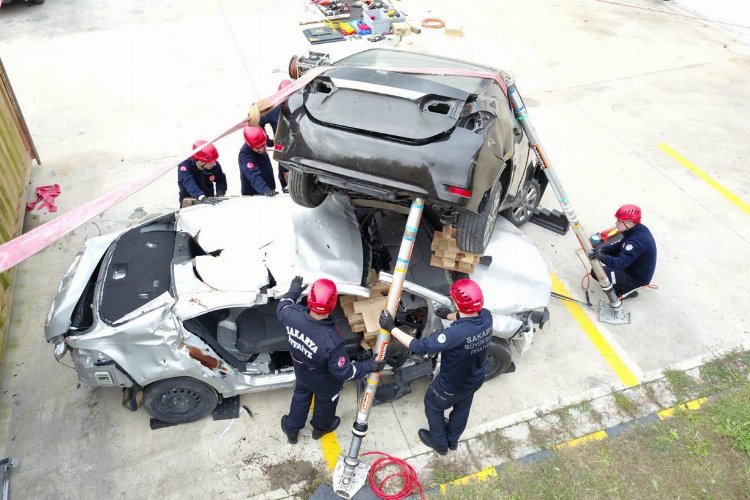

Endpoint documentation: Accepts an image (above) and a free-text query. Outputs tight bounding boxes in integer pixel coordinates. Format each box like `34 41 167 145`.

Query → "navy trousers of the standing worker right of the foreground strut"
424 375 482 448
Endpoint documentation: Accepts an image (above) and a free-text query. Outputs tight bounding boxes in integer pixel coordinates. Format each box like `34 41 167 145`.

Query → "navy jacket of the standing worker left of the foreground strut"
276 293 372 397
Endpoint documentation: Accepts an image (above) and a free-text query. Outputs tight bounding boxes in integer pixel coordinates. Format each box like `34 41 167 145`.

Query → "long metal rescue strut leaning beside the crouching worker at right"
505 77 630 325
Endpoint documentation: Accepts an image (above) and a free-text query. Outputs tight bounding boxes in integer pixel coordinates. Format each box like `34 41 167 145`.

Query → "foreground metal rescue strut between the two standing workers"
333 198 424 498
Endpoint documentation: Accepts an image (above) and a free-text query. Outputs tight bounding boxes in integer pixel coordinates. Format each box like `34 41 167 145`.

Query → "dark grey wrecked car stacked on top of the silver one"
274 49 547 254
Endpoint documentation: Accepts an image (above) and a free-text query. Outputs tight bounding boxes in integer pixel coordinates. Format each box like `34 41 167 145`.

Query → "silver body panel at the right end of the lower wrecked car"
471 217 552 315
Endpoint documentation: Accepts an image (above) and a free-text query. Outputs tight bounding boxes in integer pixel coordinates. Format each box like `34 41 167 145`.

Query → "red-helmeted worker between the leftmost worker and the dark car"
238 125 277 196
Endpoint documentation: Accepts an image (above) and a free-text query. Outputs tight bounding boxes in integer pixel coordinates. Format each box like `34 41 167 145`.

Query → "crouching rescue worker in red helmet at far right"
589 205 656 298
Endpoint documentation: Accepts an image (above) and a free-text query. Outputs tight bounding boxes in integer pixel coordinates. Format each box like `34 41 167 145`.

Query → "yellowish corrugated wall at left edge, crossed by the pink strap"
0 57 38 372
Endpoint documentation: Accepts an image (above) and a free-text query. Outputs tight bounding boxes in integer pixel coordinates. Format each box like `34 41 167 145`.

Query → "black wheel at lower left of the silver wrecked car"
143 377 219 424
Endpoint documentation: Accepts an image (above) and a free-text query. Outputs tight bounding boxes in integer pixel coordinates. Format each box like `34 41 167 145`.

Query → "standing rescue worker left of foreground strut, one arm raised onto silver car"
276 276 385 444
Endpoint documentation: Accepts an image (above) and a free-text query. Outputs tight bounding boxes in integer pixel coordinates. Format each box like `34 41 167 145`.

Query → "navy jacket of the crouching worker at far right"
600 224 656 286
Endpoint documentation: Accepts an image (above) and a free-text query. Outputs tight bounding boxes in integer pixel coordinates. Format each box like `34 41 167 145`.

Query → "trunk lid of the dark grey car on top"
305 67 471 143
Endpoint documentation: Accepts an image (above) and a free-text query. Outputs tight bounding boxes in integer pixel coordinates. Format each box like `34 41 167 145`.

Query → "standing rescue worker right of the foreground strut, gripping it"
380 279 492 455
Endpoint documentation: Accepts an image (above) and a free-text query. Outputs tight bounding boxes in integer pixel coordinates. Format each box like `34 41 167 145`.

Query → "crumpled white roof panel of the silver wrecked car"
173 194 367 318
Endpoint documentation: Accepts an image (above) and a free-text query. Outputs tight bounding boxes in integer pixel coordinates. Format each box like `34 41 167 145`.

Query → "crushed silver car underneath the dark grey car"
45 194 550 423
